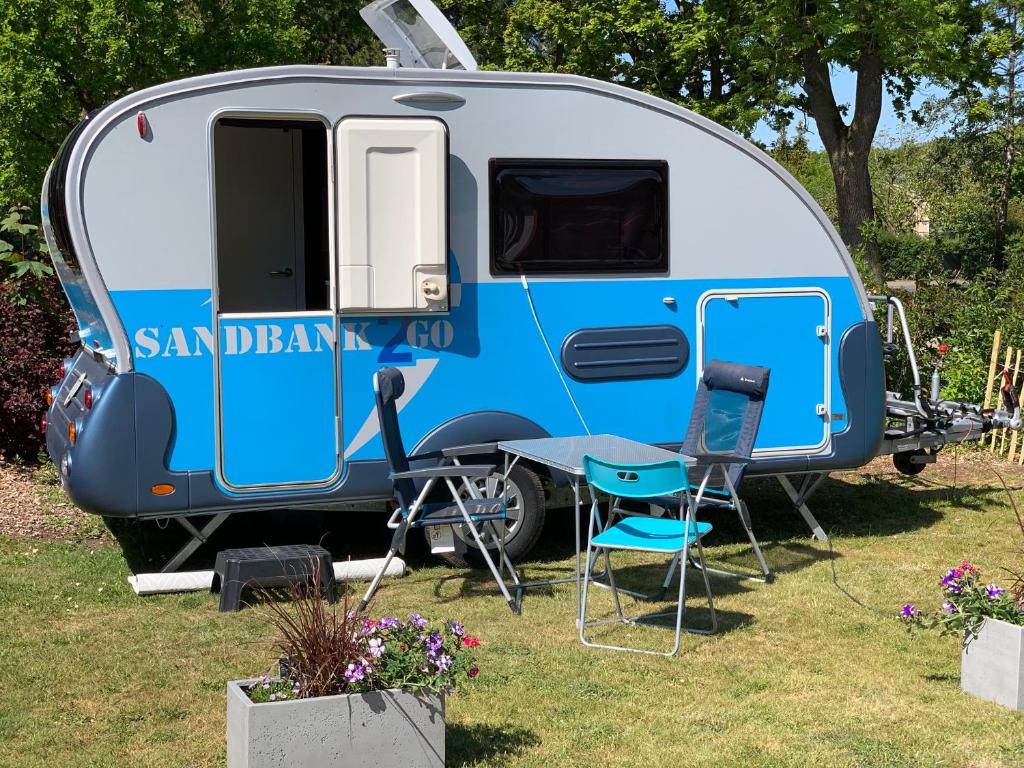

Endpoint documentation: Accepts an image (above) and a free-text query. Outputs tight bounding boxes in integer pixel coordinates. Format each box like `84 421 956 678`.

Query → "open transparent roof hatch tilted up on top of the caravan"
359 0 476 70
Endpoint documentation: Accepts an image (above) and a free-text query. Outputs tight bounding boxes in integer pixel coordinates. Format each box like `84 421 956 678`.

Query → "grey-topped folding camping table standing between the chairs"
485 434 696 626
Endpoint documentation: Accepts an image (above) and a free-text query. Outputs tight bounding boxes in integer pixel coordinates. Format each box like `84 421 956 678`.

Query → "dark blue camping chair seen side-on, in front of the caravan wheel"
358 368 521 613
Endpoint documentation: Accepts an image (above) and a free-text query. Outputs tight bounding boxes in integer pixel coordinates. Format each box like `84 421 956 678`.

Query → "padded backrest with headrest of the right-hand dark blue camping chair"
681 360 771 487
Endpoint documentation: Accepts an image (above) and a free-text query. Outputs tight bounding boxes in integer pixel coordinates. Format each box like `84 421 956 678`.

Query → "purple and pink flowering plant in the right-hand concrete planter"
900 560 1024 639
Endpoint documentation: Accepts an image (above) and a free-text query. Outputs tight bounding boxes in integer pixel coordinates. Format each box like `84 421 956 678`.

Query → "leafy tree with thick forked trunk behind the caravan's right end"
716 0 981 281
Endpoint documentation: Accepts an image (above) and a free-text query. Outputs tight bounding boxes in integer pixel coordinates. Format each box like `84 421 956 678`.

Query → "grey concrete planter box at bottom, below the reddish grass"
227 680 444 768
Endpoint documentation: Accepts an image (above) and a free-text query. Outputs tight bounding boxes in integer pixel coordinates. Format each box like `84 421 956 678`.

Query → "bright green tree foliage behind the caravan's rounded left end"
0 0 306 207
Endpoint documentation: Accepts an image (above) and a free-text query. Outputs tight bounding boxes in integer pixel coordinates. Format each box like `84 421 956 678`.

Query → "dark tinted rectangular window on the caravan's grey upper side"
490 160 669 274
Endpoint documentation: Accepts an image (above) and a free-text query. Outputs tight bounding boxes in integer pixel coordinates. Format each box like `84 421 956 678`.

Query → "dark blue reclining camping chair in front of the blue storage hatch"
613 360 772 585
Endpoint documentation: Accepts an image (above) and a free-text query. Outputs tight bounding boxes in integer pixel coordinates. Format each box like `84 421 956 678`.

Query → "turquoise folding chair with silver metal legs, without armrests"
580 456 718 656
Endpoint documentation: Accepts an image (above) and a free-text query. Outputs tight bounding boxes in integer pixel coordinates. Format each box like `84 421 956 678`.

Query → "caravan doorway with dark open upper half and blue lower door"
212 115 341 490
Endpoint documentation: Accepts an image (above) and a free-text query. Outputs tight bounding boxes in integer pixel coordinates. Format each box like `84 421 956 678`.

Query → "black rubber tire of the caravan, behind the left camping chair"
424 464 546 568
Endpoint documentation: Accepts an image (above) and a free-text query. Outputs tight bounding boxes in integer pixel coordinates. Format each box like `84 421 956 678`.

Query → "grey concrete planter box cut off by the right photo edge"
961 618 1024 710
